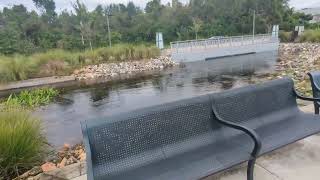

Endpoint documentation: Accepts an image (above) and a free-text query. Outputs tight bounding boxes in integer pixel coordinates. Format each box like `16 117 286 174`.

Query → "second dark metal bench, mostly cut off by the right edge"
308 71 320 114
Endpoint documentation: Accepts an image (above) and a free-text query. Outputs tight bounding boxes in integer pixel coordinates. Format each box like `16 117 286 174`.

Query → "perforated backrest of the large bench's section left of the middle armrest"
82 95 220 177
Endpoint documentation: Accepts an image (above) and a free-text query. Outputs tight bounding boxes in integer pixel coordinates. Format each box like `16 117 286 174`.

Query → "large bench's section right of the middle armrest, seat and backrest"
212 78 320 155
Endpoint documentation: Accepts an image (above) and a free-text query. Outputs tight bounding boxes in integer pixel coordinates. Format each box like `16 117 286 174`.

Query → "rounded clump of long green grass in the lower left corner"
0 109 48 179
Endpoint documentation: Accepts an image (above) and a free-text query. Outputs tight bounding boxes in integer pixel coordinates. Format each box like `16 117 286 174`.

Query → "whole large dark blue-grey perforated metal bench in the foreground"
82 78 320 180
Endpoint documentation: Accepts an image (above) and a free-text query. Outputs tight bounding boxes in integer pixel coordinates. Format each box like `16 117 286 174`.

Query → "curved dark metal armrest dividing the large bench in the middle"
212 107 261 159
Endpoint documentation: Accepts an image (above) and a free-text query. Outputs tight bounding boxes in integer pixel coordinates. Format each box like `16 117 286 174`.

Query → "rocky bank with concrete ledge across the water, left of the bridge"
0 56 178 98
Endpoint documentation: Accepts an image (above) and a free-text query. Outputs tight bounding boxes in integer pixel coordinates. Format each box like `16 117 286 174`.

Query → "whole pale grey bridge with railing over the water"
170 34 280 62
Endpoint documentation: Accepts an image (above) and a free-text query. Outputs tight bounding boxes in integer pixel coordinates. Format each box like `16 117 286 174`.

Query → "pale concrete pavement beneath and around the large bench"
73 105 320 180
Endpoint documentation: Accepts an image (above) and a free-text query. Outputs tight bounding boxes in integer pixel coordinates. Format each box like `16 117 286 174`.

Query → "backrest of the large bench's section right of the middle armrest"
211 78 298 128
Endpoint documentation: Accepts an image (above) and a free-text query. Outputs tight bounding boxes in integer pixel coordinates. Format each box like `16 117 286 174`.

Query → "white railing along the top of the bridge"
170 34 279 53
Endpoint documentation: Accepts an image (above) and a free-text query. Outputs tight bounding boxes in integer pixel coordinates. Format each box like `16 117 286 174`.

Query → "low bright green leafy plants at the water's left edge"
4 88 59 108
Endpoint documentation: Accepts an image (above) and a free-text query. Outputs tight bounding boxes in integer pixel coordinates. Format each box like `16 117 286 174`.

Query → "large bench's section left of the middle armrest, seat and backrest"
82 95 252 180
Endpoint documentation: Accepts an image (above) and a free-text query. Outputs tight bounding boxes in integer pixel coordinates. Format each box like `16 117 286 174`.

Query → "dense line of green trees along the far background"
0 0 312 55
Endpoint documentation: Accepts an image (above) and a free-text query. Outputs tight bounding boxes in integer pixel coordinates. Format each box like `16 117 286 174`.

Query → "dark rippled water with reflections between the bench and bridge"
37 52 278 147
